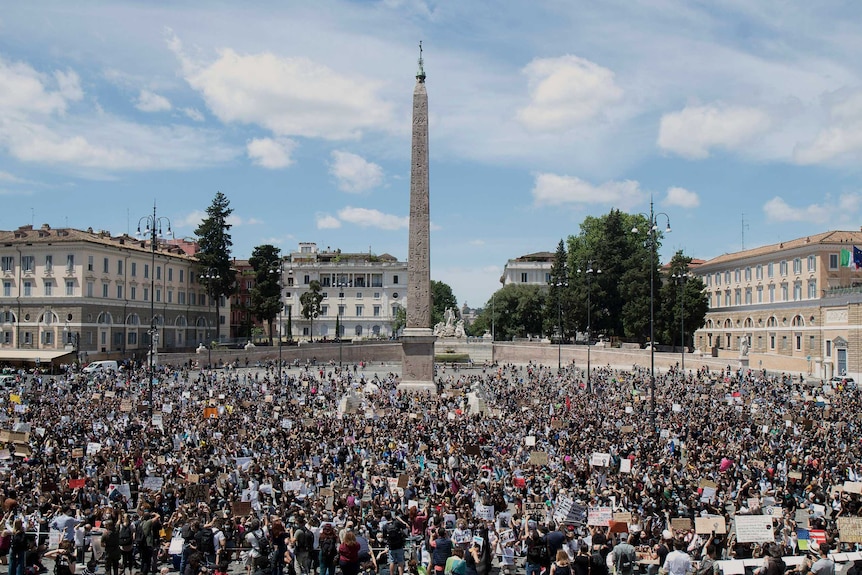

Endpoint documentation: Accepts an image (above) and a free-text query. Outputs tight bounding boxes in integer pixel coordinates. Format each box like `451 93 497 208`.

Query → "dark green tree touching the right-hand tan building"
657 250 709 347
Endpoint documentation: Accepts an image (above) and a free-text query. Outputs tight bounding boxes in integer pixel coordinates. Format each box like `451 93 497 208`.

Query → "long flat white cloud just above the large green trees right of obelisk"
531 173 645 213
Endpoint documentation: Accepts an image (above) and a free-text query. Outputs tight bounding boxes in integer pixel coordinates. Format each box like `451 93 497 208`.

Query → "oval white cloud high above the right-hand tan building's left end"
658 104 771 159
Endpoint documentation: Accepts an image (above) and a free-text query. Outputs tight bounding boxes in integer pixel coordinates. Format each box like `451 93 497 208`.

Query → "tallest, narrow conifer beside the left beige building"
195 192 236 341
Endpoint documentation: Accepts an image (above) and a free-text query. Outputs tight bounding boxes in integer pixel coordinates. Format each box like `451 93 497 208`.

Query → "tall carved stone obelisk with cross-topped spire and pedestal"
398 42 437 393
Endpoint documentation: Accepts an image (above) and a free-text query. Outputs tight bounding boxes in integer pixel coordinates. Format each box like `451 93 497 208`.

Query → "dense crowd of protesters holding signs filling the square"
0 363 862 575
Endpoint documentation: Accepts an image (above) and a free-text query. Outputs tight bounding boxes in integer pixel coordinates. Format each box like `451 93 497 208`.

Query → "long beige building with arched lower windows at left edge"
0 224 230 359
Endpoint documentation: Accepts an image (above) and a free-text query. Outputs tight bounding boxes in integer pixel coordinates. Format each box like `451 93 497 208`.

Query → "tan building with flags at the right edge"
692 231 862 378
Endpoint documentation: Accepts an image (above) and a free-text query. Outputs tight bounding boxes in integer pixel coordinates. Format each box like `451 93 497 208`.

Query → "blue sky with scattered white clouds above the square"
0 0 862 307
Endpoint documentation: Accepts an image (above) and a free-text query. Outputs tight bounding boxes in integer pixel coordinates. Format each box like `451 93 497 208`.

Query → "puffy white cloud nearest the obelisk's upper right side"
518 56 623 132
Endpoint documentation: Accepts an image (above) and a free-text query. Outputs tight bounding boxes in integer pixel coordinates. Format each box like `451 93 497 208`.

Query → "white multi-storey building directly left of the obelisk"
276 243 407 340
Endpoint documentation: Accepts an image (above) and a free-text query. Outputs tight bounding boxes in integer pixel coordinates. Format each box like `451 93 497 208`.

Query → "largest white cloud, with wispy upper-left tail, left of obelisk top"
168 34 392 140
